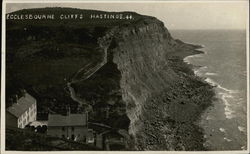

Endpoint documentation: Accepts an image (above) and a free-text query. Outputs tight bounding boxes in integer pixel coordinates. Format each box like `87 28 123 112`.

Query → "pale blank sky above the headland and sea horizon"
6 0 249 30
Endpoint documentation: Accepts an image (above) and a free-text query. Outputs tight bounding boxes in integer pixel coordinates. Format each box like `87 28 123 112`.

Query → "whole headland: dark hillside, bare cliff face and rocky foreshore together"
7 8 214 150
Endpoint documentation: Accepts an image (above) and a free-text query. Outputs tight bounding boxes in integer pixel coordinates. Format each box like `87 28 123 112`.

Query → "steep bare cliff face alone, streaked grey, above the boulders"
112 21 176 135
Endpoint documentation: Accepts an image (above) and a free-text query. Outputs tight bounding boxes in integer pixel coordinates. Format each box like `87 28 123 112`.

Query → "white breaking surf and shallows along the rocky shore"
184 46 246 150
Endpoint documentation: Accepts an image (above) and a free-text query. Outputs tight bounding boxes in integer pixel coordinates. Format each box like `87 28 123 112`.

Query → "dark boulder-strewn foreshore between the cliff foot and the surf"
136 44 215 151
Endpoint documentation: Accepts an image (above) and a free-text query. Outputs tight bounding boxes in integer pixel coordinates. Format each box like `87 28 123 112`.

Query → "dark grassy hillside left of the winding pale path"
7 8 135 110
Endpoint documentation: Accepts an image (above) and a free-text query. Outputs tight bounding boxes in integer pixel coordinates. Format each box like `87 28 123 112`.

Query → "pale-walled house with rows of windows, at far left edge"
6 91 37 128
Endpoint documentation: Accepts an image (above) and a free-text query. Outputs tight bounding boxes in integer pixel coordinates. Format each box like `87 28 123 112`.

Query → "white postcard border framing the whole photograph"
0 0 250 154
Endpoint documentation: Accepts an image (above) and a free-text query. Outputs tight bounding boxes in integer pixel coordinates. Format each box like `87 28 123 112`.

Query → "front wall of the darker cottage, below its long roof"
47 126 88 141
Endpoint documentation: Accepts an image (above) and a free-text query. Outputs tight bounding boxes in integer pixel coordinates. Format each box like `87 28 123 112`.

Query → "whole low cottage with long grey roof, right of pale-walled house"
47 112 93 143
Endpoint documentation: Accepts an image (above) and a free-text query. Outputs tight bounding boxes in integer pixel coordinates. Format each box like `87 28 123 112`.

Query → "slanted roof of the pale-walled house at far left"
7 93 36 118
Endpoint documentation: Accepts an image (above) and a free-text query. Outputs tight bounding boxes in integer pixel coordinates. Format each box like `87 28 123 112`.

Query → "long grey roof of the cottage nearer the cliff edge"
48 114 87 126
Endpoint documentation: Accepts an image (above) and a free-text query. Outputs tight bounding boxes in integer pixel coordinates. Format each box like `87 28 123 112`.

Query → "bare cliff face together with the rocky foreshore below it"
97 19 213 150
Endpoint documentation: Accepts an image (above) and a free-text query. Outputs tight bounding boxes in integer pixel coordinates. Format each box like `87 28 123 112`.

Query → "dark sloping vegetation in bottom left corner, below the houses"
6 128 100 151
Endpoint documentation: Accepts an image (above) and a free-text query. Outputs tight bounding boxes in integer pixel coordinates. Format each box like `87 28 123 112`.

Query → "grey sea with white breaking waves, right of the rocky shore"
170 30 247 150
